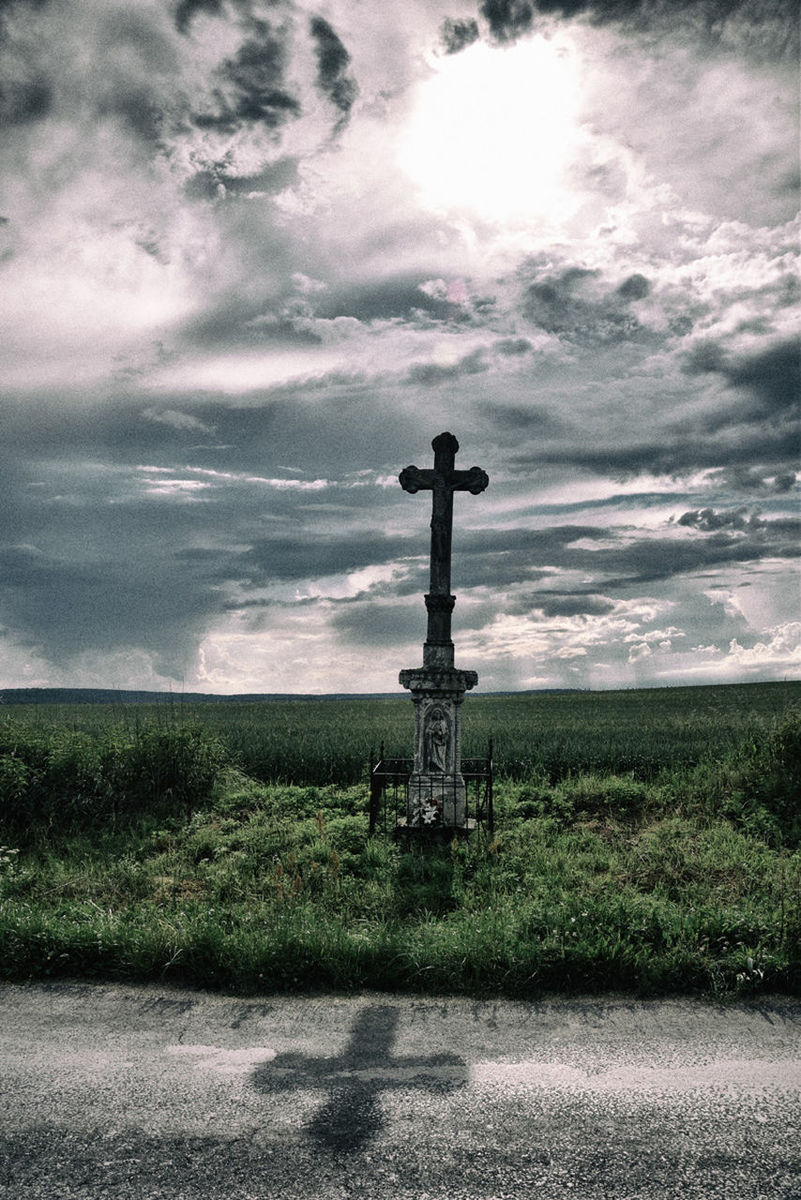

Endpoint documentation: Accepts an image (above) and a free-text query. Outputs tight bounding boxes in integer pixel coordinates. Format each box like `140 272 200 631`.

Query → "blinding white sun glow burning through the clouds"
399 36 580 222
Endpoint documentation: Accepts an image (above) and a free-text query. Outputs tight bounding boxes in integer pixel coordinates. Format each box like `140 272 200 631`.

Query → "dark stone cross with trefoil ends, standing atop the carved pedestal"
399 433 489 667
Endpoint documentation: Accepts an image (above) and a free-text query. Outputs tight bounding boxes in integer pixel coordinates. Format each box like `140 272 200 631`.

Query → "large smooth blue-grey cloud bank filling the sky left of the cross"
0 376 428 677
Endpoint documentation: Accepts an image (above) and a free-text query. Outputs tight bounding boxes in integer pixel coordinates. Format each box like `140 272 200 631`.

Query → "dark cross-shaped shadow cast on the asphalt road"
254 1004 468 1153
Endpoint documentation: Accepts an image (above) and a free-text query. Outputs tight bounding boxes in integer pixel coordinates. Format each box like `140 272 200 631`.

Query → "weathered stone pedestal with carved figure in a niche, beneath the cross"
401 667 478 828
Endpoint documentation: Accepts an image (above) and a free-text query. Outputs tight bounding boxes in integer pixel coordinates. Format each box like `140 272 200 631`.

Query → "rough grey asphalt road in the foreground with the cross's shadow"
0 984 801 1200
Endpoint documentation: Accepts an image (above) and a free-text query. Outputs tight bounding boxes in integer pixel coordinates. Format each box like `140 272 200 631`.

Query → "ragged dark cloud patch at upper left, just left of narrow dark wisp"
193 20 301 132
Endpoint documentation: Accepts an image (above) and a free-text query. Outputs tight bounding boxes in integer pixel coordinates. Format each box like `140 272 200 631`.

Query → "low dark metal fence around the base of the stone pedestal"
369 739 495 836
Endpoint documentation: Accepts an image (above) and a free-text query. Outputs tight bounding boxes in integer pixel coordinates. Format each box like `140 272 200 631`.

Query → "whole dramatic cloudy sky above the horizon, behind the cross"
0 0 801 695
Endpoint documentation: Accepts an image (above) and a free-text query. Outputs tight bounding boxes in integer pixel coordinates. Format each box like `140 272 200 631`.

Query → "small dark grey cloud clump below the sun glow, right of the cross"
523 266 649 346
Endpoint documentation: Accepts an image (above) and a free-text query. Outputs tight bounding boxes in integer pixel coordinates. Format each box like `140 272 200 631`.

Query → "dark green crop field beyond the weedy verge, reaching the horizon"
0 683 801 786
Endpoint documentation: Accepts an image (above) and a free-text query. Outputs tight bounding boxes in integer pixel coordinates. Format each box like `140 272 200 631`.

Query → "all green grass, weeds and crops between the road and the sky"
0 683 801 997
